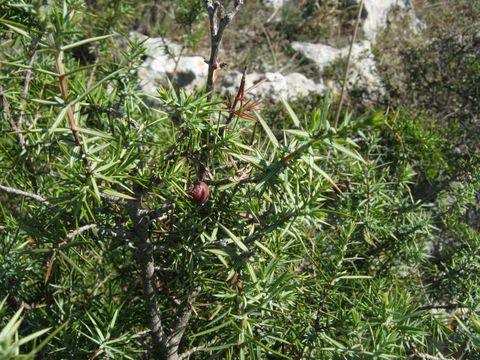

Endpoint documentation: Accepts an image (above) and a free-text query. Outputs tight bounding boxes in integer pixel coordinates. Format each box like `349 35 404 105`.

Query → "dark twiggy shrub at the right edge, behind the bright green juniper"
382 28 480 126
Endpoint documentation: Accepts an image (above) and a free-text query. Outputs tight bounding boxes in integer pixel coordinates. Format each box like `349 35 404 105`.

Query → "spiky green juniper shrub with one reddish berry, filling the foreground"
0 0 479 359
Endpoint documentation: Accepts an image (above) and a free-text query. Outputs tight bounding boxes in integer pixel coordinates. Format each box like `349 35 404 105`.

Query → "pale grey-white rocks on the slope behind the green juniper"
132 0 418 104
